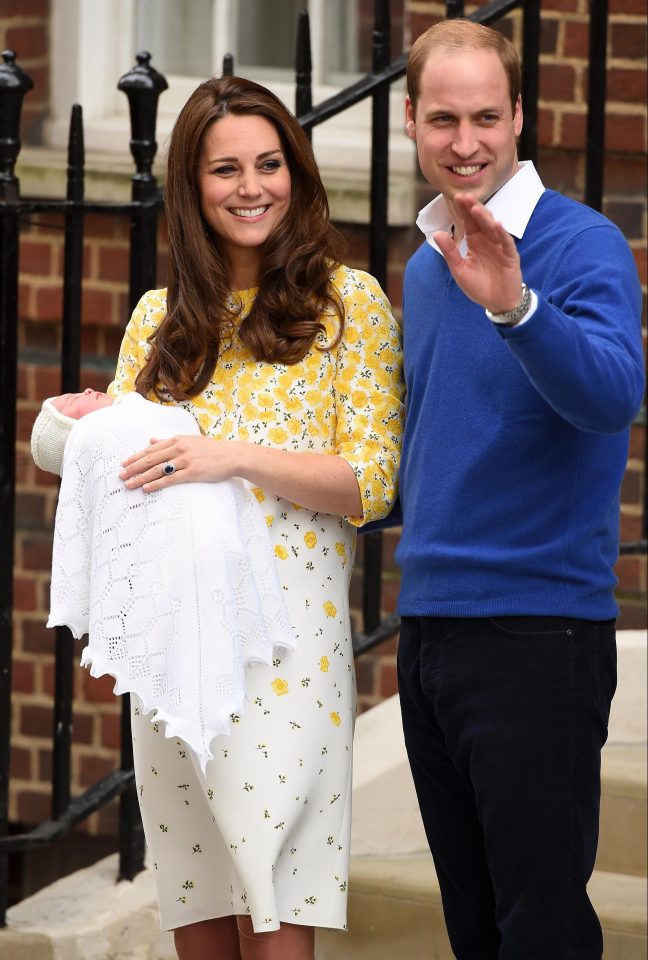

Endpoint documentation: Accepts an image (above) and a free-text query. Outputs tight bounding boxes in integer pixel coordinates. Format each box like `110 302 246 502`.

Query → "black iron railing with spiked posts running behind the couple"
0 0 646 926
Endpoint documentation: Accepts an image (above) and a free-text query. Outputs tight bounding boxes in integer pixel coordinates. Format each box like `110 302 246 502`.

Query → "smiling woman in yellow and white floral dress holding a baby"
110 77 403 960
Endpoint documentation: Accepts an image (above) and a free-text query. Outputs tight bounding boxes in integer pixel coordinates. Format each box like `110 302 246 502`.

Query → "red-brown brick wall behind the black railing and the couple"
0 0 647 833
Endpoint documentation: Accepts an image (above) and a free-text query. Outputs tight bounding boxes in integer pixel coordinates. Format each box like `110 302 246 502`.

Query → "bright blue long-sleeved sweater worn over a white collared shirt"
396 190 643 619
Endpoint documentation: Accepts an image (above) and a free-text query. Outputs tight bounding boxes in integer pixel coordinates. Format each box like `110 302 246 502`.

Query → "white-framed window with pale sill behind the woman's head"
45 0 414 217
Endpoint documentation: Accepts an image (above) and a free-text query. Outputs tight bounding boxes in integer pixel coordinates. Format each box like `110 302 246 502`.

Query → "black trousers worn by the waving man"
398 617 616 960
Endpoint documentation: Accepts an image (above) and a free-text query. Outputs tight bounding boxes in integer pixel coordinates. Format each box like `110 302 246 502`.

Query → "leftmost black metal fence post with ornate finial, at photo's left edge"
0 50 34 927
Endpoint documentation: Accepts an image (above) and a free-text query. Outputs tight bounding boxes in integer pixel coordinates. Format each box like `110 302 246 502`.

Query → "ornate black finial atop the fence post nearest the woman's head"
117 50 169 181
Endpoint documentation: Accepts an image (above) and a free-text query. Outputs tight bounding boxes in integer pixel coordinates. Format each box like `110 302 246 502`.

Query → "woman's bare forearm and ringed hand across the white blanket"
120 436 362 517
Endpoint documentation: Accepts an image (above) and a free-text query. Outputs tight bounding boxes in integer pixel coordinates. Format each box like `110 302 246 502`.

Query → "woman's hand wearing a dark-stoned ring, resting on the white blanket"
119 435 243 493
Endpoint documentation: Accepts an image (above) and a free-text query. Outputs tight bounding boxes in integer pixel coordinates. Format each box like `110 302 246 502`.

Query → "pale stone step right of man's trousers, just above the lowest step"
596 744 648 877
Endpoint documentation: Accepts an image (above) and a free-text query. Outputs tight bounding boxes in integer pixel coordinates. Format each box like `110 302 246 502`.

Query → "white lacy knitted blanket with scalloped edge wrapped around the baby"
47 393 296 771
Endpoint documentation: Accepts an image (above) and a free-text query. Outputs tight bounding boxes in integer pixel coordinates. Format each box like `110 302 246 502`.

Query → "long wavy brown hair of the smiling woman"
136 77 344 400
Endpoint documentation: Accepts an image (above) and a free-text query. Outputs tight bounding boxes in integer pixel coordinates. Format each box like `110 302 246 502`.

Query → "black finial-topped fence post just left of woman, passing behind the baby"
117 51 168 880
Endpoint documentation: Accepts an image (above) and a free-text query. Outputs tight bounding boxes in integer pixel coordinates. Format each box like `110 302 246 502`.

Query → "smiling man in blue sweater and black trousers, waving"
396 20 643 960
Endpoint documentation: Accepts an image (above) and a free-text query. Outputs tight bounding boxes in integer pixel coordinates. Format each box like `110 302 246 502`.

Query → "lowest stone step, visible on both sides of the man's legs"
315 855 648 960
